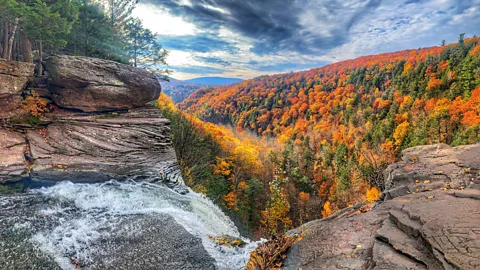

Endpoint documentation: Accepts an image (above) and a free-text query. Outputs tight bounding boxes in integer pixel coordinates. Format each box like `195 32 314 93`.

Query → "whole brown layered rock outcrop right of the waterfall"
284 144 480 270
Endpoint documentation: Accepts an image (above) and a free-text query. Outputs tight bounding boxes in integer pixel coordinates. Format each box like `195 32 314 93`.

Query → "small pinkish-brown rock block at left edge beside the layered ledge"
0 128 28 184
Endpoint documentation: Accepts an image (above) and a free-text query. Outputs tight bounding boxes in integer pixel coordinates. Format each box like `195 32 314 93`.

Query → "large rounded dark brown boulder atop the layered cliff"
46 55 161 112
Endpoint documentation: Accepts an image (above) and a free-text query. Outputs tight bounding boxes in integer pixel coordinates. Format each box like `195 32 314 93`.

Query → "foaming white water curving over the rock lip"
30 181 258 269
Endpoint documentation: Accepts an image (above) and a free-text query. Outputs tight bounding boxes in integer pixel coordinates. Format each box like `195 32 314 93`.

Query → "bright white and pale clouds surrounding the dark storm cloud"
134 0 480 79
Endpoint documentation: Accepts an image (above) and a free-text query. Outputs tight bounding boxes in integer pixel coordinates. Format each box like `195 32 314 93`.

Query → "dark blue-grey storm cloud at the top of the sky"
142 0 381 55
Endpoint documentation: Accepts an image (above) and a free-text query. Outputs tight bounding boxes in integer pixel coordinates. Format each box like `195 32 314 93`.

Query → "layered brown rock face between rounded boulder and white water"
26 108 181 190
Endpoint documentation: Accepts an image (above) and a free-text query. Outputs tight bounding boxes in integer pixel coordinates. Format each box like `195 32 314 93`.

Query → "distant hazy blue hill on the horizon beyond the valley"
160 77 243 103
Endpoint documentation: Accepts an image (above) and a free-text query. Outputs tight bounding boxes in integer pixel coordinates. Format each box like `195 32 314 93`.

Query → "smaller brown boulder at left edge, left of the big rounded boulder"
0 59 35 118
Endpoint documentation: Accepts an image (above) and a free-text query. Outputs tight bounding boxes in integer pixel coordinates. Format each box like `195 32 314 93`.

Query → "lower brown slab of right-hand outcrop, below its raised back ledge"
284 191 480 270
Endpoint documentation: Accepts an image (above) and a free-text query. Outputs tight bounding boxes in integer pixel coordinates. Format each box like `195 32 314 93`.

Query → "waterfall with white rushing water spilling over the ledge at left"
0 180 258 269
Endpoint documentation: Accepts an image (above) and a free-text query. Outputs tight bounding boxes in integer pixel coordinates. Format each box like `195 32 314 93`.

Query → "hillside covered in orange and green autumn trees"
177 38 480 231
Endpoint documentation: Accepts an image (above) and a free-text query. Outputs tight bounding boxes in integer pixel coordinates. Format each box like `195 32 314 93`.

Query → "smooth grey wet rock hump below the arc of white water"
87 215 216 270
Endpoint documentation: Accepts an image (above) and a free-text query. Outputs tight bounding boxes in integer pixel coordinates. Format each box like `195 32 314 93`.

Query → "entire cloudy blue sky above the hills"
133 0 480 80
